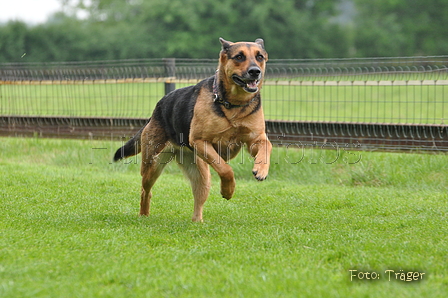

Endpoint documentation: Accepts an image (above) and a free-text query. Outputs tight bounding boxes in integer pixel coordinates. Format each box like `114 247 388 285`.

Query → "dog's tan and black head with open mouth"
219 38 268 93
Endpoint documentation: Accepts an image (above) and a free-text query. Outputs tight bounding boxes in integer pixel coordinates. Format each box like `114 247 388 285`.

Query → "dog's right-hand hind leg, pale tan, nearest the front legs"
178 152 211 222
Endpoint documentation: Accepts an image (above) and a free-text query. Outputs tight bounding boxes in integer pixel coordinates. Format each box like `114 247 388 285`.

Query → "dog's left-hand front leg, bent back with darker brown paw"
191 140 235 200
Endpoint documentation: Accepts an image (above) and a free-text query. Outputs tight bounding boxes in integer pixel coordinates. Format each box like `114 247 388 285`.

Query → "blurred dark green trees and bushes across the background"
0 0 448 63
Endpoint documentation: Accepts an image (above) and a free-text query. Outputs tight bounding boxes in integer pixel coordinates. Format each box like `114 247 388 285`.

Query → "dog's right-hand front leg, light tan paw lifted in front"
247 134 272 181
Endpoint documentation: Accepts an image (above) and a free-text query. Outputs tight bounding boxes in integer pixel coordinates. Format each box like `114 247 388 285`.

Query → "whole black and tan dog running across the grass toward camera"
114 38 272 222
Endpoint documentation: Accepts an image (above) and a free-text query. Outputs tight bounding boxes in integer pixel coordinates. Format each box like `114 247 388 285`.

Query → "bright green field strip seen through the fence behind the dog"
0 83 448 124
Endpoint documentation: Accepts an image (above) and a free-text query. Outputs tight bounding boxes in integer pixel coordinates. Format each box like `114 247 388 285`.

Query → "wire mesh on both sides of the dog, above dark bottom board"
0 56 448 124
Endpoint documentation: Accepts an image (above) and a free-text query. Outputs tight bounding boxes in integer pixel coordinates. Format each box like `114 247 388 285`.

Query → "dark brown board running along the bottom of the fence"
0 116 448 152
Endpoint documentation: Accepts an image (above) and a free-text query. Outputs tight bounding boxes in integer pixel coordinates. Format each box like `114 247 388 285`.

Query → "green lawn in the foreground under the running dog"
0 138 448 298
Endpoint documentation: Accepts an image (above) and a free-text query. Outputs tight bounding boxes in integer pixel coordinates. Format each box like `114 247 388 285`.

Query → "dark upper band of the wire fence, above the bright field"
0 56 448 81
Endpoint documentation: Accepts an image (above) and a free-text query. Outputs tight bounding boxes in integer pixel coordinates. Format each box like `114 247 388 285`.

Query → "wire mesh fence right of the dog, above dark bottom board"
264 57 448 124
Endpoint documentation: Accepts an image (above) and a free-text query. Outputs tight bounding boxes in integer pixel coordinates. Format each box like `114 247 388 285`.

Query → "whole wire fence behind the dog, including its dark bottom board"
0 56 448 151
